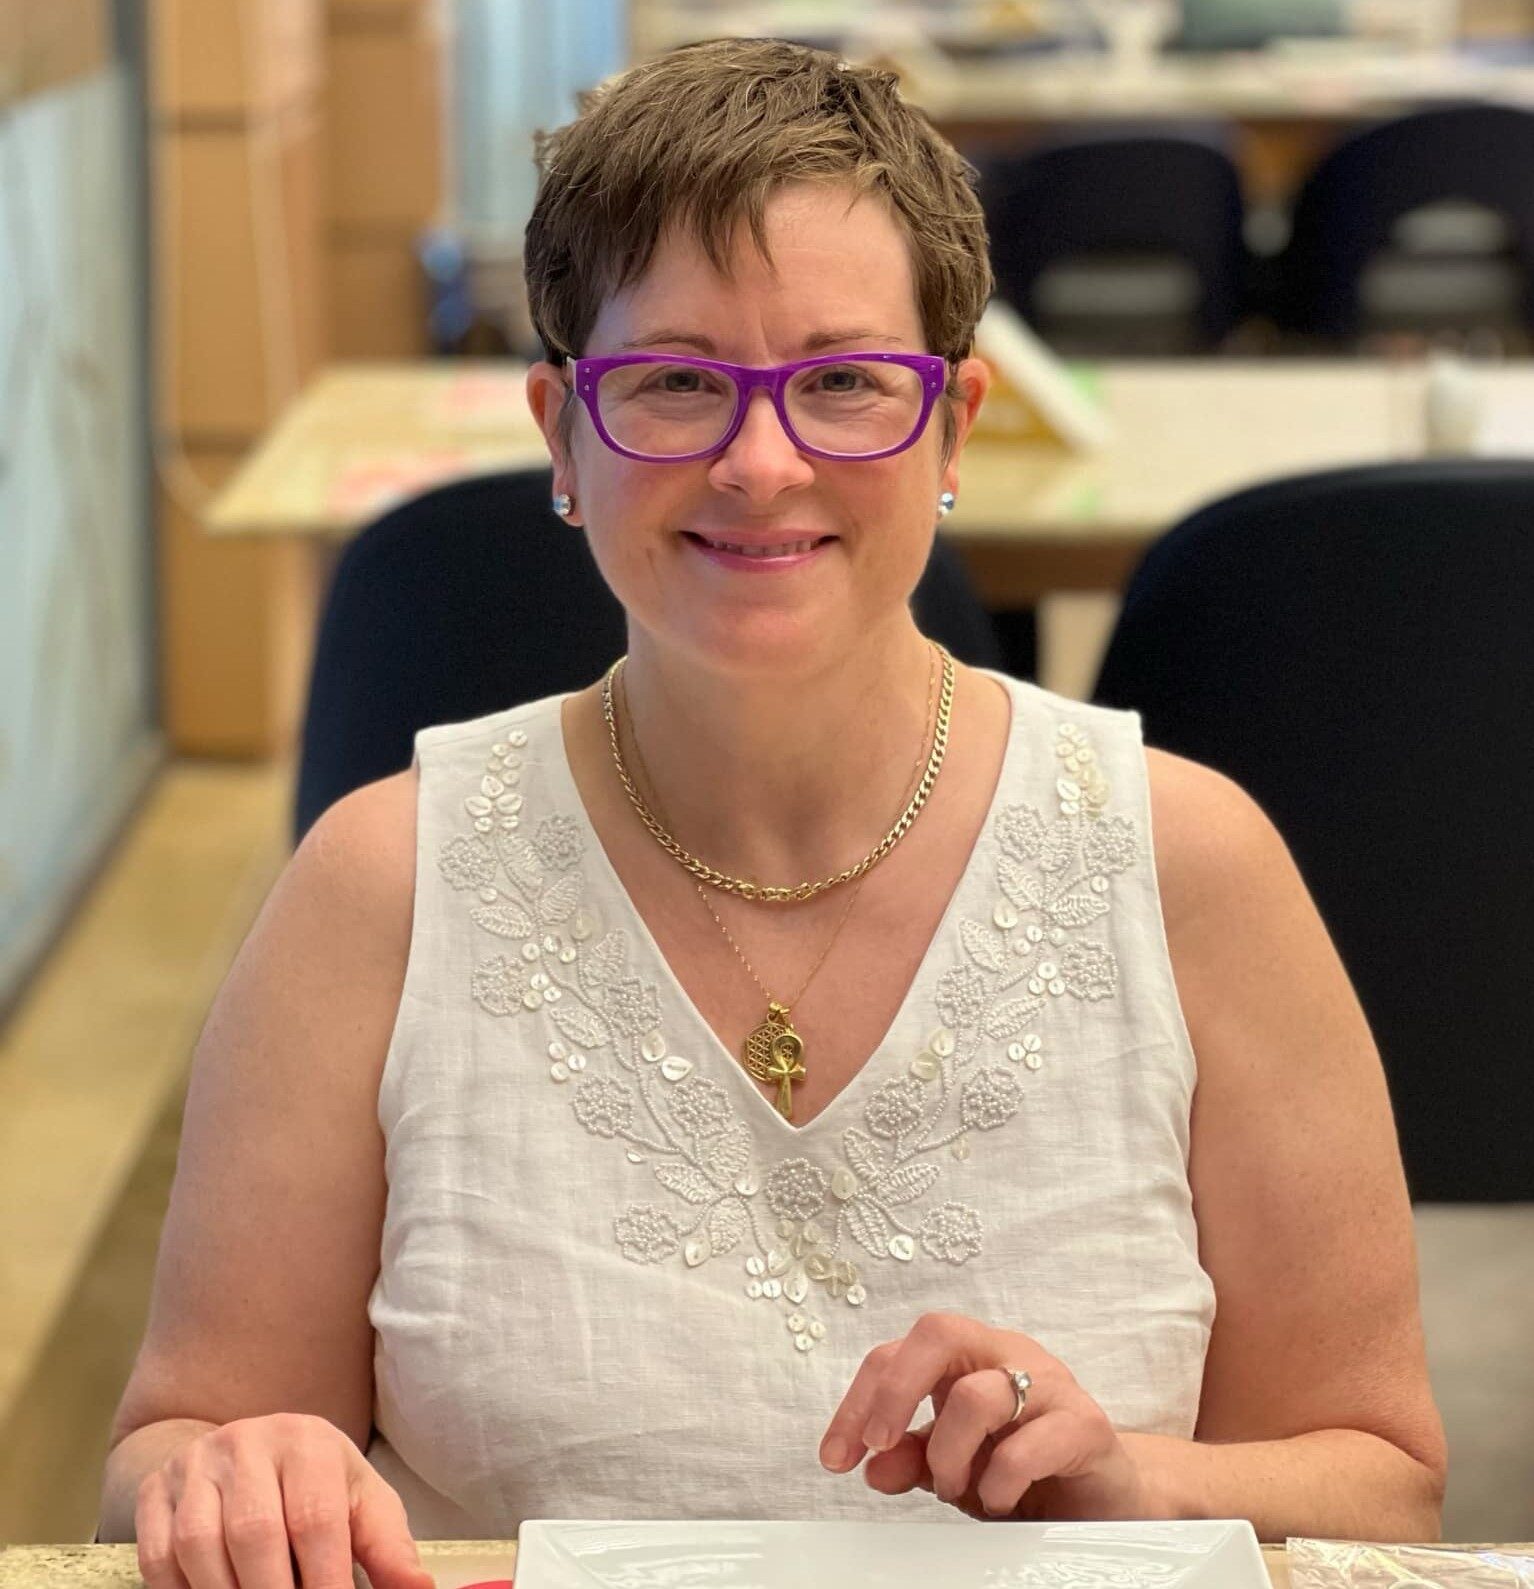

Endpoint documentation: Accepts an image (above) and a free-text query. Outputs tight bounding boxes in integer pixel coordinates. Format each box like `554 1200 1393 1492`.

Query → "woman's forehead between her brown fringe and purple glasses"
591 183 922 351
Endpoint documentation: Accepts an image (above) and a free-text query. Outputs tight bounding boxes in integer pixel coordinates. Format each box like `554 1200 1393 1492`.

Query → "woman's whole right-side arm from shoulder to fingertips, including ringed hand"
820 753 1443 1540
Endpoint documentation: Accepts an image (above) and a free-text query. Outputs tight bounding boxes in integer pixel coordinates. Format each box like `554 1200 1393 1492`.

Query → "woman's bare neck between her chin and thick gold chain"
615 617 938 883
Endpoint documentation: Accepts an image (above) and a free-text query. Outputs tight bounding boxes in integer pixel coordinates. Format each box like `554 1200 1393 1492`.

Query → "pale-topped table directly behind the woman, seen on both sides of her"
207 359 1534 607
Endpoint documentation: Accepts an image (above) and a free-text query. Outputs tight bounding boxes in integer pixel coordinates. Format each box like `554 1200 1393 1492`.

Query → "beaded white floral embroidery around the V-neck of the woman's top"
437 723 1140 1352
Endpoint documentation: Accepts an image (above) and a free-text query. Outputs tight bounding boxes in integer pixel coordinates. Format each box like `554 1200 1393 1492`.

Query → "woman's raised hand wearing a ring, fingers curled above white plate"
820 1313 1149 1521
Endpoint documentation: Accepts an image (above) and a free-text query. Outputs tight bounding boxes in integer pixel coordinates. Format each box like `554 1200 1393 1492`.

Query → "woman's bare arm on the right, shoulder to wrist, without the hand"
1125 752 1445 1538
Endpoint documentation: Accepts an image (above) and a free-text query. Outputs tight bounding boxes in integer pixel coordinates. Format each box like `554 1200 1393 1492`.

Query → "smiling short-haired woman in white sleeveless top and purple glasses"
105 41 1443 1589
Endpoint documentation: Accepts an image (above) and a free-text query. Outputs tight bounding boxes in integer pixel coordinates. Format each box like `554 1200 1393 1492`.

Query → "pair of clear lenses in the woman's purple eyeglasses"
596 359 922 458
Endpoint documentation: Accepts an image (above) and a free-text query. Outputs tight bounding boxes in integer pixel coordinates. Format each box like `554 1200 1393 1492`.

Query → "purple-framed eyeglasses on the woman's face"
571 353 947 464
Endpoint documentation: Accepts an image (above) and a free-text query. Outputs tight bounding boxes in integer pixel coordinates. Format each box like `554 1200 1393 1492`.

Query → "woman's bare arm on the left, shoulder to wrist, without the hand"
102 774 415 1540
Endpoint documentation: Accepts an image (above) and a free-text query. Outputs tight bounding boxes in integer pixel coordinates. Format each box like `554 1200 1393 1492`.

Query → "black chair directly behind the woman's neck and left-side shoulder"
294 469 1001 839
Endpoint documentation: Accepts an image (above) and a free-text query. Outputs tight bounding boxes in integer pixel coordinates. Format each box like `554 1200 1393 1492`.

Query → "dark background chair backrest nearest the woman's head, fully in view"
981 133 1246 346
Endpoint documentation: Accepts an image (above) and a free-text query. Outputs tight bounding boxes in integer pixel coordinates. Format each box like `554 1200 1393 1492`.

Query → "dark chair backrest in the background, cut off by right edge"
1275 105 1534 338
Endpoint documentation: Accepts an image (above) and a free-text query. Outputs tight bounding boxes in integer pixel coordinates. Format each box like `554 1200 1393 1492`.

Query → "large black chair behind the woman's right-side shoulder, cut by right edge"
1095 461 1534 1201
